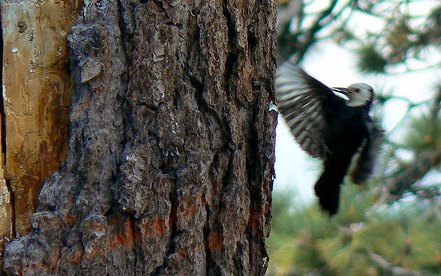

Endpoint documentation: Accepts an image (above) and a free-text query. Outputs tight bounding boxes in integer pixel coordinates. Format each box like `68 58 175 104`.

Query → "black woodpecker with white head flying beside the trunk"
276 61 383 216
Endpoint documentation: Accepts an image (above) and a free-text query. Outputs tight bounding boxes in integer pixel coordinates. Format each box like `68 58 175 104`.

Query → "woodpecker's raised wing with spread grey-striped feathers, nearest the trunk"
276 61 343 158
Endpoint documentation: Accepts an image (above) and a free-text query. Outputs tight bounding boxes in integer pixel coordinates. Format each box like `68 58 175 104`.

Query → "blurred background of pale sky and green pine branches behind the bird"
268 0 441 275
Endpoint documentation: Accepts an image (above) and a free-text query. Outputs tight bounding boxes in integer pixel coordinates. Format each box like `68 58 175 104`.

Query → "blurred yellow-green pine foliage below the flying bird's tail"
268 183 441 275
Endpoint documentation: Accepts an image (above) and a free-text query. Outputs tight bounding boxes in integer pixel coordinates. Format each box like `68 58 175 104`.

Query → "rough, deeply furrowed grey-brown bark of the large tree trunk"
4 0 276 275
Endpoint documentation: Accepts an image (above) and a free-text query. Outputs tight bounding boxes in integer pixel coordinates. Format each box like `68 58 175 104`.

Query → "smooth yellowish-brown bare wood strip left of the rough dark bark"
0 0 81 269
